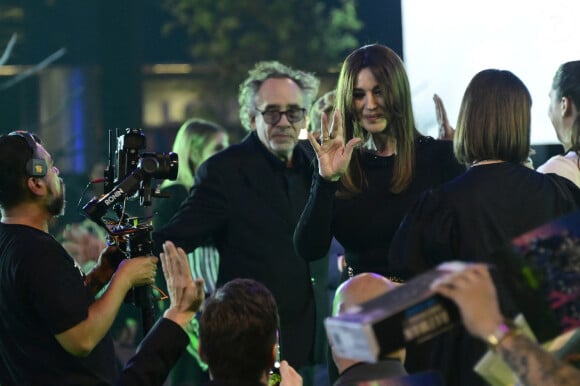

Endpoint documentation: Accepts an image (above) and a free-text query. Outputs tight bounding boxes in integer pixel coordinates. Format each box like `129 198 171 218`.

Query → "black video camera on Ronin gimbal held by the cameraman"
83 129 178 333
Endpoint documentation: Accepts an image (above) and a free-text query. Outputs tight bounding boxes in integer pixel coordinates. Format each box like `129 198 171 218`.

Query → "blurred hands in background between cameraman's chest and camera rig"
62 223 107 266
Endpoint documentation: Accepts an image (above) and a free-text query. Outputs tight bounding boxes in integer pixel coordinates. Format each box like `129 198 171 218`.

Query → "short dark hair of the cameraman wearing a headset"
0 135 39 209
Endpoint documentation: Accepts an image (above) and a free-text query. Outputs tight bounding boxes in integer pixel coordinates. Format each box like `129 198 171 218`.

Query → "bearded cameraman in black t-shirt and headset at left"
0 132 201 386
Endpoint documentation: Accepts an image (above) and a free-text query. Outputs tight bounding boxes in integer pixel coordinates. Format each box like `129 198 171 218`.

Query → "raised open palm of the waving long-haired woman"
308 110 361 181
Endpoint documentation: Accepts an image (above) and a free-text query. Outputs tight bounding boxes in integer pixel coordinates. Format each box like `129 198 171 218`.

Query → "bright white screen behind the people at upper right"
401 0 580 144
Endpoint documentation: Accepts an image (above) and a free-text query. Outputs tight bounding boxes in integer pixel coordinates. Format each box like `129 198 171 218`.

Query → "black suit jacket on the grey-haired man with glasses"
153 132 328 367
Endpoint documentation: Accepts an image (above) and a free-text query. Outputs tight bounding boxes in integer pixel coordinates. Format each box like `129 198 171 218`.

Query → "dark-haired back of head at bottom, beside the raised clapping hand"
199 279 278 384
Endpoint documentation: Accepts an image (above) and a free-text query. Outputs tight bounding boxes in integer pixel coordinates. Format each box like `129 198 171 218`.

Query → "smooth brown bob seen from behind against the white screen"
453 69 532 165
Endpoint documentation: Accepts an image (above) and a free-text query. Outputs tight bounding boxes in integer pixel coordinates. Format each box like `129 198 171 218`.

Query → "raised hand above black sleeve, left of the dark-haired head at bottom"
160 241 205 328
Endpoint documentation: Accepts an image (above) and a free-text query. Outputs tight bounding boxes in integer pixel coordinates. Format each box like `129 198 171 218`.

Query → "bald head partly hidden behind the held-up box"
332 273 405 373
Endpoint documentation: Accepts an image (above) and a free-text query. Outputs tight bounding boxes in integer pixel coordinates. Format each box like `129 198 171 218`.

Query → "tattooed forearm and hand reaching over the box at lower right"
434 264 580 386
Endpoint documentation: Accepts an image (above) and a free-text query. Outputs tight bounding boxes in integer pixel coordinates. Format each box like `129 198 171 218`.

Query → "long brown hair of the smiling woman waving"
336 44 419 196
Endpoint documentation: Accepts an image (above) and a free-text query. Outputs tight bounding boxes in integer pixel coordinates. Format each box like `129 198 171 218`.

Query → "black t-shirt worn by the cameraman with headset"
0 223 117 386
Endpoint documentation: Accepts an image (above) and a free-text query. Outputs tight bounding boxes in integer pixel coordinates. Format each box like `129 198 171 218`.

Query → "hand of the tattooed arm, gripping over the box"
431 264 503 339
